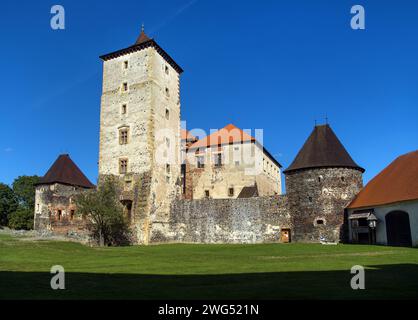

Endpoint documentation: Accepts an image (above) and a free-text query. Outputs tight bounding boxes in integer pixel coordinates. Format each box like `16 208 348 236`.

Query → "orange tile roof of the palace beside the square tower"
189 124 255 149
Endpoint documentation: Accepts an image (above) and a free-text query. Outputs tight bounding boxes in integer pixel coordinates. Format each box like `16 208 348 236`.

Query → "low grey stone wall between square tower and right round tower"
160 196 292 243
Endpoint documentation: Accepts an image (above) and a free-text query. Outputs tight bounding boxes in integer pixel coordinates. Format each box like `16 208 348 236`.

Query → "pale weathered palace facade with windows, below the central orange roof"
186 142 282 199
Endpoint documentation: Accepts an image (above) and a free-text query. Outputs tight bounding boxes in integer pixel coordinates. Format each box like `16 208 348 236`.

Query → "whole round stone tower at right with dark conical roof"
284 124 364 242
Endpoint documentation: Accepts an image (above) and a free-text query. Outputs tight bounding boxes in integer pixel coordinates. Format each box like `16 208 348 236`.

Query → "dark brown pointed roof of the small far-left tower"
38 154 94 188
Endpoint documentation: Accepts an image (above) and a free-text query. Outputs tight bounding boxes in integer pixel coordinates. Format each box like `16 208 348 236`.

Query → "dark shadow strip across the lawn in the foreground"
0 264 418 299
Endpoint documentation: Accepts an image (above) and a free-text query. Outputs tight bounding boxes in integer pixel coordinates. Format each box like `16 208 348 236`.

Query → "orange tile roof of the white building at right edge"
348 150 418 208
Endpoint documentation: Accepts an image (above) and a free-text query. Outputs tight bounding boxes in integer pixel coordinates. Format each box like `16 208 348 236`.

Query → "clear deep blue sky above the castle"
0 0 418 188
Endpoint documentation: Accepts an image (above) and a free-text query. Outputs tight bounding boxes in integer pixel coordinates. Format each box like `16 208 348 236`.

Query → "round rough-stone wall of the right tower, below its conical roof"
286 168 363 242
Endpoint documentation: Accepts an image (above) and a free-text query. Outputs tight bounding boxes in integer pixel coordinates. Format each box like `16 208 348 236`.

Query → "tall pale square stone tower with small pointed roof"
99 29 183 244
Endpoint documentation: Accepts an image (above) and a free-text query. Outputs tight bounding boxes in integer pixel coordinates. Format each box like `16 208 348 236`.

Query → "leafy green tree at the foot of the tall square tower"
75 179 130 246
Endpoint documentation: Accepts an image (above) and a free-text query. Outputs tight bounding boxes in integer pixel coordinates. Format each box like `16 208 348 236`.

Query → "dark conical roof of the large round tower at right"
284 124 365 173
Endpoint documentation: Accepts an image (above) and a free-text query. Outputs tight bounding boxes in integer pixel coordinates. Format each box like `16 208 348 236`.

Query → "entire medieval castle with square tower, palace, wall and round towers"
35 30 364 244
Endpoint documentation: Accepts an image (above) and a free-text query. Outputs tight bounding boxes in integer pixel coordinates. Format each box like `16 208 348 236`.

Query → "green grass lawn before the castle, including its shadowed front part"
0 235 418 299
